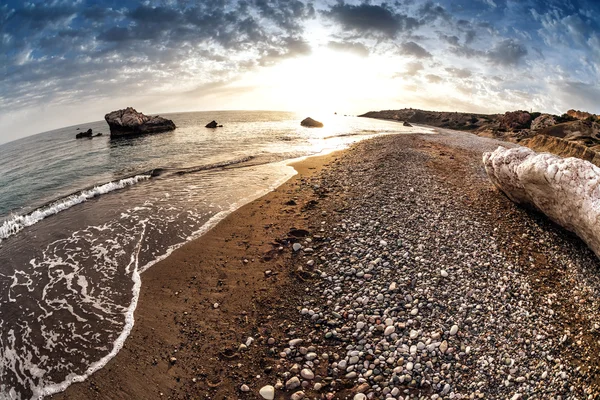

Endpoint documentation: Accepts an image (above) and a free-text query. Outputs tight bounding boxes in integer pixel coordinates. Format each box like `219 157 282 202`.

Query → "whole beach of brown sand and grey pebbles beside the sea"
52 130 600 399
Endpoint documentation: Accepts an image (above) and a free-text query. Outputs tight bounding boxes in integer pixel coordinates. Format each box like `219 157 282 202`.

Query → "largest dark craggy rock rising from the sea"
104 107 176 137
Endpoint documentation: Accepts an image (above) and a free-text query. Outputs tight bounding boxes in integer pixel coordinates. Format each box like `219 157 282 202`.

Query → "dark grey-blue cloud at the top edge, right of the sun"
323 1 420 38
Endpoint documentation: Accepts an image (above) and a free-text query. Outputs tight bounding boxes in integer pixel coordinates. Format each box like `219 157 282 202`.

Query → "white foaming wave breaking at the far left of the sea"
0 175 152 242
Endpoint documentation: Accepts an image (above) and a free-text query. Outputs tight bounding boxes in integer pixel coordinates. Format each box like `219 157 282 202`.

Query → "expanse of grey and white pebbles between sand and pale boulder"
255 132 600 400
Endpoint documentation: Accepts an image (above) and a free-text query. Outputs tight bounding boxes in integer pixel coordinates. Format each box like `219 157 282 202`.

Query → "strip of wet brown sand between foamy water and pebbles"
53 153 337 399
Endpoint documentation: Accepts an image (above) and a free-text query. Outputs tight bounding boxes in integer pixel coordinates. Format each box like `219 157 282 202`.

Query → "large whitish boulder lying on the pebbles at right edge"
483 147 600 257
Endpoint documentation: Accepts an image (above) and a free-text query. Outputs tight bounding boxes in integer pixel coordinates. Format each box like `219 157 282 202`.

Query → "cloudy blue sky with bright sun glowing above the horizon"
0 0 600 143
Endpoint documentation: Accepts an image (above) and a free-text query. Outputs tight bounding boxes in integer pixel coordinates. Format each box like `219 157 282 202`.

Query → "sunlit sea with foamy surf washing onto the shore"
0 111 431 399
